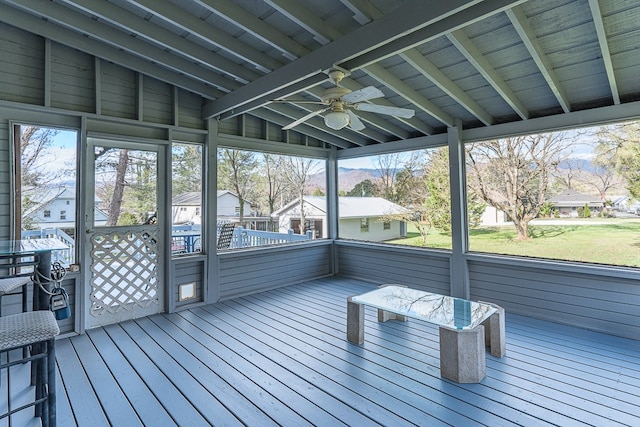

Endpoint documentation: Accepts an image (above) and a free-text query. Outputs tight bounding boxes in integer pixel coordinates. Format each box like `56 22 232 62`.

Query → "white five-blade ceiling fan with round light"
273 70 415 131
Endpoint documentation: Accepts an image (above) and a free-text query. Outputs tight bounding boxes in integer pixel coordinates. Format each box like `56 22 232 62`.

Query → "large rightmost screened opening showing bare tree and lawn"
466 122 640 267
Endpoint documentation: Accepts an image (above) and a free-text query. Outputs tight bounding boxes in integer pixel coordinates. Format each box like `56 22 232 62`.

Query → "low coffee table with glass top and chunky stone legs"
347 285 506 383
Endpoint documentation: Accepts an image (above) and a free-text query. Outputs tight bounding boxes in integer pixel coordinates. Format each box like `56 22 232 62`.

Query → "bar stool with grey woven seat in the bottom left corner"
0 310 60 427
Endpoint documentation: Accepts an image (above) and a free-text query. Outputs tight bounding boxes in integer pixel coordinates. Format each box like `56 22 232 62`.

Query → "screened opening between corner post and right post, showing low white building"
338 147 451 249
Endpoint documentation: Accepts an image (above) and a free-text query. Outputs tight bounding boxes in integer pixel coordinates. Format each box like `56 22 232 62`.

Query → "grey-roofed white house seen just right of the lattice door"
171 190 269 230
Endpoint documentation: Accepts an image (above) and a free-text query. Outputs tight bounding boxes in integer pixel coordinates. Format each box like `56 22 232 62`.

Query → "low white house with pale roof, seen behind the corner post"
272 196 409 242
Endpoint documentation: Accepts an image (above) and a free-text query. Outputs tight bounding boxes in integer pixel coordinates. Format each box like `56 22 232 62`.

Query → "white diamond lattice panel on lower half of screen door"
90 230 158 316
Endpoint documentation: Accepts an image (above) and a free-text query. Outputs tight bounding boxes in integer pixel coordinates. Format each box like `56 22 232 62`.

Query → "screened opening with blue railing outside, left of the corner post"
216 148 327 250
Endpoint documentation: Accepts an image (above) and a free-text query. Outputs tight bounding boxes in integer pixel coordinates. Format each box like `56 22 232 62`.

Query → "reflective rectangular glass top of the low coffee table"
351 285 497 329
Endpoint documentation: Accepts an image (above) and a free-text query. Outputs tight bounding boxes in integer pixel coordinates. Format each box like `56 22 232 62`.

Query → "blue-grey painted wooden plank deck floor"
48 278 640 427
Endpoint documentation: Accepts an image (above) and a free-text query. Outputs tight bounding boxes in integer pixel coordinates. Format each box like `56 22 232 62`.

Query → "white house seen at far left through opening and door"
24 186 107 230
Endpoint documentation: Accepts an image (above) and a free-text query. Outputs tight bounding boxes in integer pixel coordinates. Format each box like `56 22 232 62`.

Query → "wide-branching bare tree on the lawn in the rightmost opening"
467 133 569 240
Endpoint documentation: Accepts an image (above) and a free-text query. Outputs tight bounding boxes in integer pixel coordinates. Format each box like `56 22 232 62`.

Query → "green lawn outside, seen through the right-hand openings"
389 218 640 267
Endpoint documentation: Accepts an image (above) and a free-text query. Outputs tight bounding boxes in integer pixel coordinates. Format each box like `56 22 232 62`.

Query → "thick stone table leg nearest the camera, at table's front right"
440 325 487 383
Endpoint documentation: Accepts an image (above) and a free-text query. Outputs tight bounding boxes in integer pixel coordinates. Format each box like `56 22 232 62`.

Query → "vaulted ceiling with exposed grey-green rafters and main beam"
0 0 640 148
